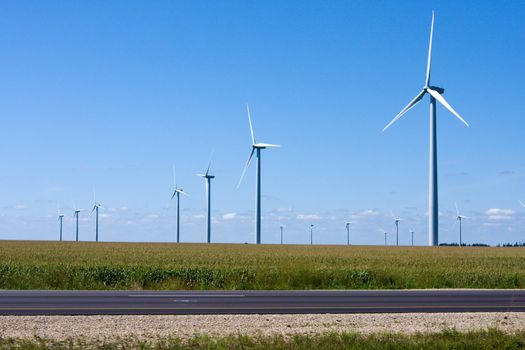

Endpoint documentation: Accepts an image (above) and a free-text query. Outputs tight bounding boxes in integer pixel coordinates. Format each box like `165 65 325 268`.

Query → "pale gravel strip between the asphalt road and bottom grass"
0 312 525 341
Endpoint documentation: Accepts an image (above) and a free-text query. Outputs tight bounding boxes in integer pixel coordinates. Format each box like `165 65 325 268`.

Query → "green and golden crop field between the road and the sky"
0 241 525 289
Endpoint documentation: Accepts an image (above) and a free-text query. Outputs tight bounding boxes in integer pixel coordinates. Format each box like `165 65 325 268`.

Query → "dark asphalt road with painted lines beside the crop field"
0 290 525 315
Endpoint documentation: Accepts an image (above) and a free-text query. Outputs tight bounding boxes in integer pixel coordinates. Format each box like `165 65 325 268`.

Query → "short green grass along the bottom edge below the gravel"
0 329 525 350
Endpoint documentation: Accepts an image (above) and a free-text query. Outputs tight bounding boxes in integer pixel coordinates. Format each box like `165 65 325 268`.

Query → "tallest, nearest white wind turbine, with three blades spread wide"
383 11 468 246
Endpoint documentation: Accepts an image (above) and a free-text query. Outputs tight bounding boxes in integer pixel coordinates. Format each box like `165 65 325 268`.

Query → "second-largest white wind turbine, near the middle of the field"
237 105 281 244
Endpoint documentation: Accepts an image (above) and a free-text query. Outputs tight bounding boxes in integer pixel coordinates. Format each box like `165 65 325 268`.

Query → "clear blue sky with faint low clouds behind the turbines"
0 1 525 244
